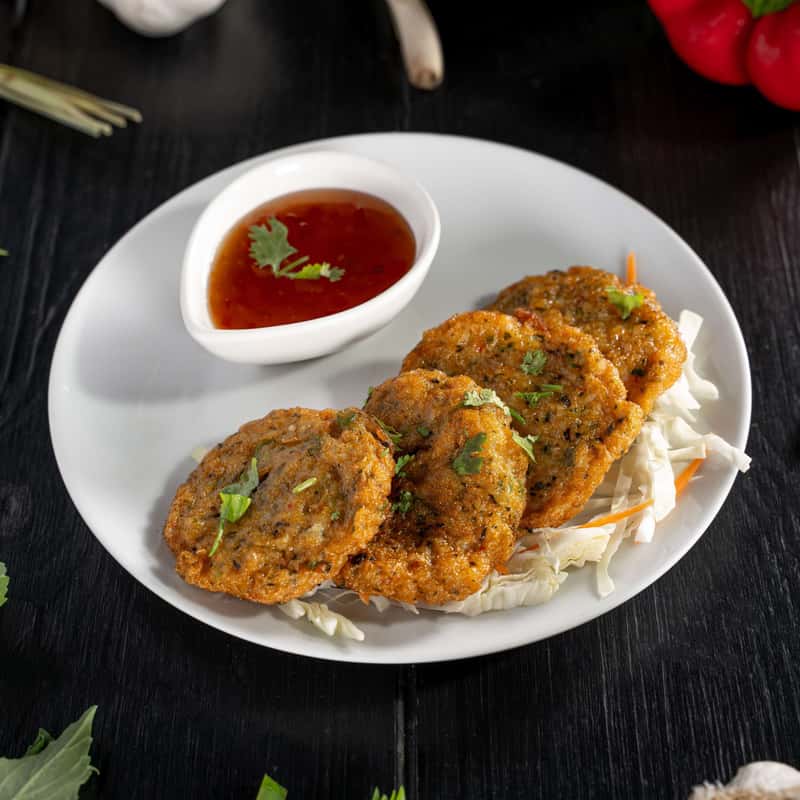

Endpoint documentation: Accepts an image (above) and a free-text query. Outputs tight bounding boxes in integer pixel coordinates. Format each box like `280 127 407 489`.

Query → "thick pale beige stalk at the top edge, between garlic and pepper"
386 0 444 89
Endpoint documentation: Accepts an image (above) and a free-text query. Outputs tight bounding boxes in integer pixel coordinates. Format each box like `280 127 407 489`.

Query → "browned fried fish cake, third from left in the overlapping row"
403 311 643 528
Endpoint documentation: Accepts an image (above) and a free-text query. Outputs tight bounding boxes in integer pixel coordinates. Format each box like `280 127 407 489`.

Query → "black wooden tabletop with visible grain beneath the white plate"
0 0 800 800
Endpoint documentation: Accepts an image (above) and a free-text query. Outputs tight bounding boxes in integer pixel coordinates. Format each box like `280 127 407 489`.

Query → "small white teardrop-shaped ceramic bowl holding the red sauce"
180 151 440 364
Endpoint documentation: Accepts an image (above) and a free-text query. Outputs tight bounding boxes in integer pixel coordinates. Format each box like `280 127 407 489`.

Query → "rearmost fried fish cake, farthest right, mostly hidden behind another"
489 267 686 416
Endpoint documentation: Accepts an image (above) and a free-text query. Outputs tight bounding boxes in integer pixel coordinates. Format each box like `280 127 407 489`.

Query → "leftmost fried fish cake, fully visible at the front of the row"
164 408 394 603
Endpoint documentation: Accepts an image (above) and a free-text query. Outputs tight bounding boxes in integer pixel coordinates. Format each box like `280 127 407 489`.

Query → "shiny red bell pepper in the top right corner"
648 0 800 111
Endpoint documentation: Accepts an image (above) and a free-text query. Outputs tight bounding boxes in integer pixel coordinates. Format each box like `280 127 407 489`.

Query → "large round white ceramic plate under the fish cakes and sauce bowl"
49 134 750 663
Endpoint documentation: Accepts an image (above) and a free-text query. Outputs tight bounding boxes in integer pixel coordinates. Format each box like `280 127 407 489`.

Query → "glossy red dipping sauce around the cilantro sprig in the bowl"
208 189 416 328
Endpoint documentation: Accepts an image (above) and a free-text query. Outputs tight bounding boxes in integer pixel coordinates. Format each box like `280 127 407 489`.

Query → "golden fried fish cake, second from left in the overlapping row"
336 370 527 605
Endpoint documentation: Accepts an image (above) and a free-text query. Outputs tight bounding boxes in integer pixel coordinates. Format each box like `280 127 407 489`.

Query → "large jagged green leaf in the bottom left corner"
0 706 97 800
